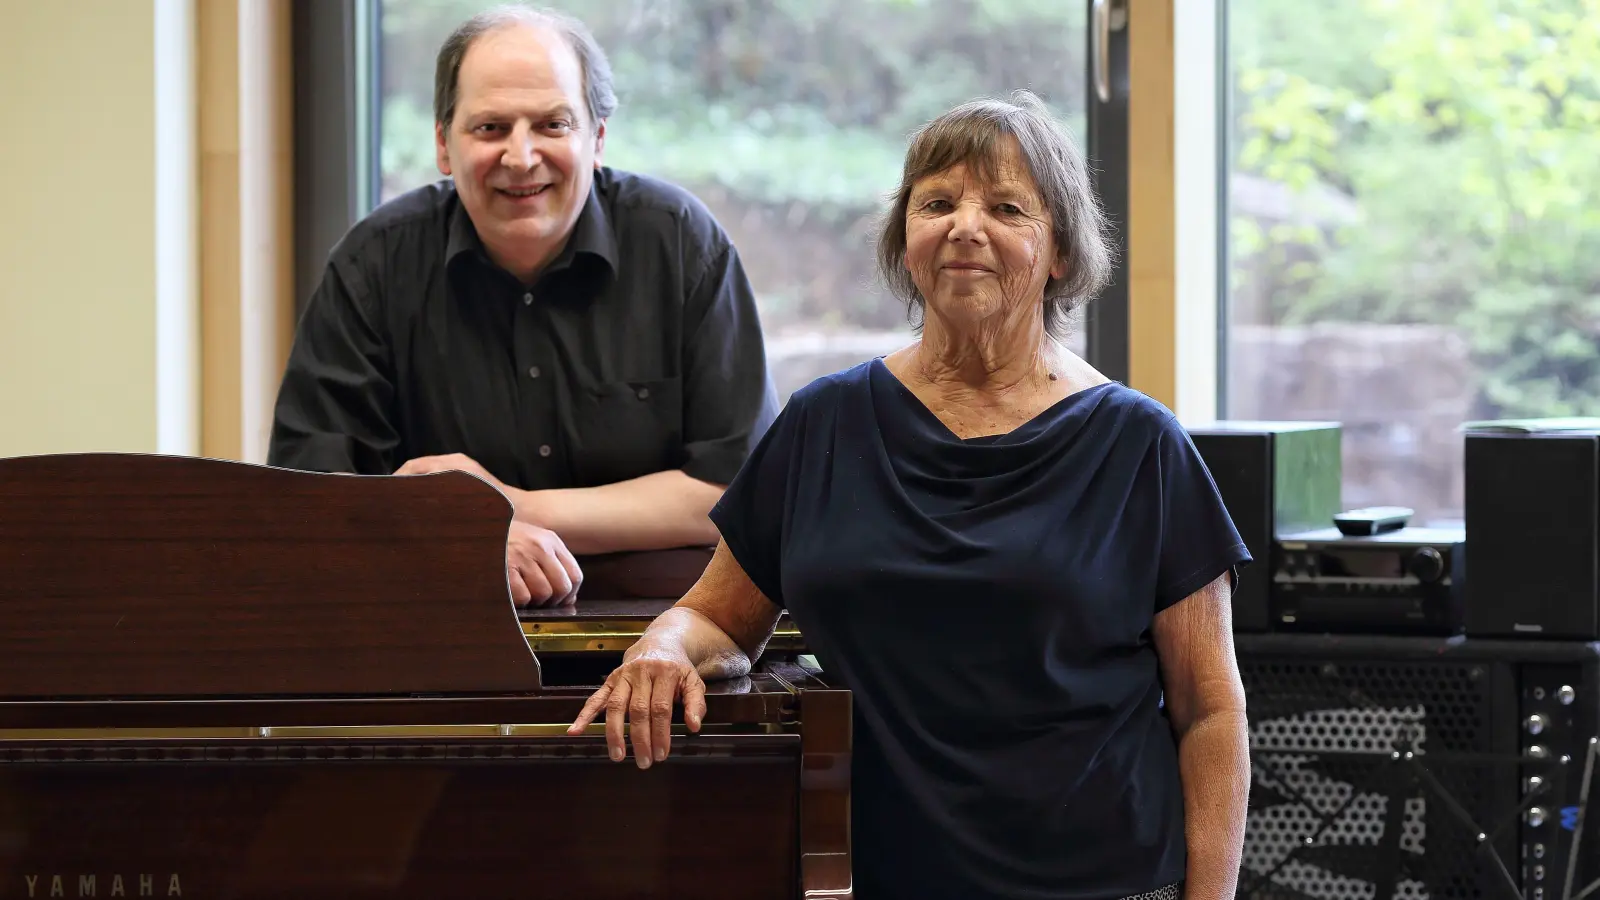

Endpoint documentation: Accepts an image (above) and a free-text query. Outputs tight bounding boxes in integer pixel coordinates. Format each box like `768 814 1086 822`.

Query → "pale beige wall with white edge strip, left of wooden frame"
0 0 198 456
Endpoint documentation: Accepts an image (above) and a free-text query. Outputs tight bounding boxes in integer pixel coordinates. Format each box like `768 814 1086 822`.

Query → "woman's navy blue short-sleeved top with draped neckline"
712 359 1250 900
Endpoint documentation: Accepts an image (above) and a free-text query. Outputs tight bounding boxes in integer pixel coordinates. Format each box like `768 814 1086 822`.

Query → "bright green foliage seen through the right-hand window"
1230 0 1600 416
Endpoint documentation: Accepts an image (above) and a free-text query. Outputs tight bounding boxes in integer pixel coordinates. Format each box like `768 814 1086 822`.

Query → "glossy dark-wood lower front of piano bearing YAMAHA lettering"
0 665 850 900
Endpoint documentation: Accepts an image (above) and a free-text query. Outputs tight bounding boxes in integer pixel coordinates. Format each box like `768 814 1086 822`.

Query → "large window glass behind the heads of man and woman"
378 0 1088 397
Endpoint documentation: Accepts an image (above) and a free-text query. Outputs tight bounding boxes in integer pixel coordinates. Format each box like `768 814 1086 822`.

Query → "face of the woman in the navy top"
906 139 1066 328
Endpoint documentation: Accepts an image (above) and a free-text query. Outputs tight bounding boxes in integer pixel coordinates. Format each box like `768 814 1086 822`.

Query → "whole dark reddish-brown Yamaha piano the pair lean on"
0 453 851 900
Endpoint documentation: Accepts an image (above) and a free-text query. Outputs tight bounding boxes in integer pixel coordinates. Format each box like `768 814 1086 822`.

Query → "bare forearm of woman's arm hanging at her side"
1178 711 1250 900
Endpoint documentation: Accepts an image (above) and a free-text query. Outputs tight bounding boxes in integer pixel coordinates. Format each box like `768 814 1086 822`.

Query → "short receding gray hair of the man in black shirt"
434 3 616 128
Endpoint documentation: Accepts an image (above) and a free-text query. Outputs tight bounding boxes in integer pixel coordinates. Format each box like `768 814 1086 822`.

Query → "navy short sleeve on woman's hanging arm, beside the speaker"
1155 416 1251 612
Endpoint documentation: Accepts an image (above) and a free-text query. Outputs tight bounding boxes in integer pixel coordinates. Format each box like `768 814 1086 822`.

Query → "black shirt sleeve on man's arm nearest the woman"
683 240 778 485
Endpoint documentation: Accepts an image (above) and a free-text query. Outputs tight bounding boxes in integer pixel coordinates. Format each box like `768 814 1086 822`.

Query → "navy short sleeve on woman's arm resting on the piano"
710 394 805 605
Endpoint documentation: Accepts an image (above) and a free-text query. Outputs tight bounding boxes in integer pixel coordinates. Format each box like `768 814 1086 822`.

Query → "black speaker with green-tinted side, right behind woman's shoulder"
1187 421 1342 633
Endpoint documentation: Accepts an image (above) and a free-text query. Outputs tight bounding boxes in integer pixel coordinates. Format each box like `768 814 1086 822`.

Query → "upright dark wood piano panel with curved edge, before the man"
0 453 539 700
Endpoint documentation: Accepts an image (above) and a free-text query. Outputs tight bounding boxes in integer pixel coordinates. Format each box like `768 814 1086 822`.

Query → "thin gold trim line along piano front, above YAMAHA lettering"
0 721 795 736
